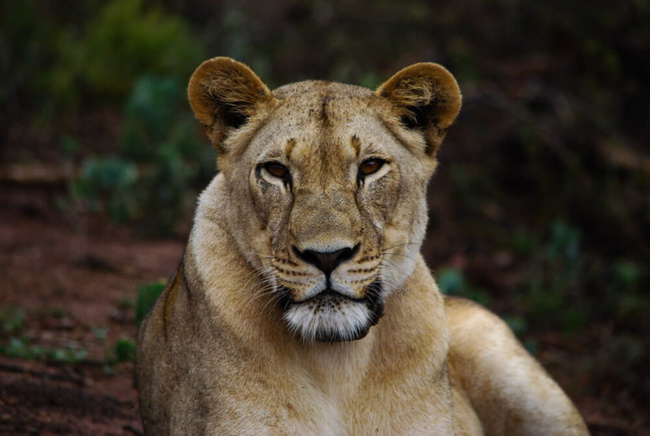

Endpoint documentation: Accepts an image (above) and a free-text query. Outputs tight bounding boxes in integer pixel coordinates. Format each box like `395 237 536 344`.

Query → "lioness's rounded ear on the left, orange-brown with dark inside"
187 57 272 151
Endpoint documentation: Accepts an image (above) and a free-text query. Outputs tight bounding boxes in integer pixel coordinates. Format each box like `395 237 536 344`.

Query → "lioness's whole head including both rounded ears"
190 58 460 341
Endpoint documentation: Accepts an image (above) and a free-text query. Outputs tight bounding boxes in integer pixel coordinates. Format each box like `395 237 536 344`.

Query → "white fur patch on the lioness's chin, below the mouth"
284 296 371 342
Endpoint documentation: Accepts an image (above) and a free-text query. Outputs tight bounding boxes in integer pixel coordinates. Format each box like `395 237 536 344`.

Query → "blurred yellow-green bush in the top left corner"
0 0 205 126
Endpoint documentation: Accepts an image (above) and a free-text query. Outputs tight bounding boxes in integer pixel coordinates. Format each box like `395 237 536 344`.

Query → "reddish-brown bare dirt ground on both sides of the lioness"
0 182 650 435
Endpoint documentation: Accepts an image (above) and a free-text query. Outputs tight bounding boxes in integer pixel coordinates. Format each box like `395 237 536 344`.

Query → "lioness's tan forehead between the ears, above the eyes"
250 81 396 163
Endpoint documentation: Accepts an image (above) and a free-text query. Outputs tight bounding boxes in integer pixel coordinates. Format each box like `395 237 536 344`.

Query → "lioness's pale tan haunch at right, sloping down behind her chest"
445 297 588 435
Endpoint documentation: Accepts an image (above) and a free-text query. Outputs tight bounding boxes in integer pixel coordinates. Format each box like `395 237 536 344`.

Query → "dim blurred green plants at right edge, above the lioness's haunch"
513 220 650 333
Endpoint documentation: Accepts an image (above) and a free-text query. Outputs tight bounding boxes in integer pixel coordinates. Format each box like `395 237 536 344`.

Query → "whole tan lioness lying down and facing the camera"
137 58 587 435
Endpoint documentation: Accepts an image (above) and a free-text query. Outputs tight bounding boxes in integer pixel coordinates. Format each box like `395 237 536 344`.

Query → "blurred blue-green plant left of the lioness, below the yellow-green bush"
74 75 215 237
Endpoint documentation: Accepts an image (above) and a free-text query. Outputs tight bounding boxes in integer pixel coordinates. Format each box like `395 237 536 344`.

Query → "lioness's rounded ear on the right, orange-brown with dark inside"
376 62 462 155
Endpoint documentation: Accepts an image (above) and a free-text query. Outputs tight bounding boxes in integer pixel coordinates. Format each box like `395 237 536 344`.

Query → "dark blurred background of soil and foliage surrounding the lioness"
0 0 650 435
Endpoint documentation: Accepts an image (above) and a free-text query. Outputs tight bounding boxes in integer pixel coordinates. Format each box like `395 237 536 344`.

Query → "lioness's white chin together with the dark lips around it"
280 282 384 342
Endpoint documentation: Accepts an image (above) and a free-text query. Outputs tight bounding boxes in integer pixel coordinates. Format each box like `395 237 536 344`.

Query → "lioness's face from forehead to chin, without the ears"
243 83 426 341
